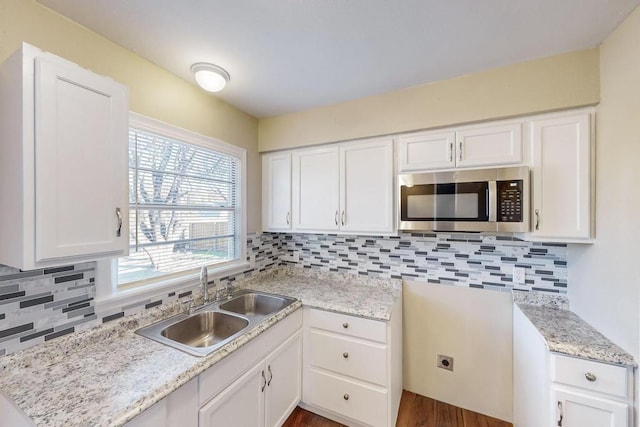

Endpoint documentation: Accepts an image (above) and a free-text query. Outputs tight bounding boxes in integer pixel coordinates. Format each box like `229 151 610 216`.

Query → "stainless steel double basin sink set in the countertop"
136 290 297 356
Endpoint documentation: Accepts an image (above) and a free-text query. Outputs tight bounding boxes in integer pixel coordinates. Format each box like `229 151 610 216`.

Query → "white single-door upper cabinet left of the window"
0 44 129 269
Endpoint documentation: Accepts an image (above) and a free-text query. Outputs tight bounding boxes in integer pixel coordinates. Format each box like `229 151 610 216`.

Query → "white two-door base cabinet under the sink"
196 311 302 427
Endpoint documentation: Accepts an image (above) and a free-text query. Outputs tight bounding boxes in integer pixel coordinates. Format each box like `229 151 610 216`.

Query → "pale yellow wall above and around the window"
0 0 261 232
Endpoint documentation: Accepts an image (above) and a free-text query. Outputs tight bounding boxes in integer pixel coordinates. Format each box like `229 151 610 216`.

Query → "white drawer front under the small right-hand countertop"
552 356 627 398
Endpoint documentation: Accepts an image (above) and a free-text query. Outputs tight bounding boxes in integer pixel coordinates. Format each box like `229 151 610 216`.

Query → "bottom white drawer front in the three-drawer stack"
305 369 388 426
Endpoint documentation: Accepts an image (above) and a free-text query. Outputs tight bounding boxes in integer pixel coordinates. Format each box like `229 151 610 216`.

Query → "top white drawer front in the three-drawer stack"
309 309 387 343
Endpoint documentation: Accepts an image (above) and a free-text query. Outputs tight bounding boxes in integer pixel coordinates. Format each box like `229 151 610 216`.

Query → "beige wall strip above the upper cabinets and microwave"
259 49 600 151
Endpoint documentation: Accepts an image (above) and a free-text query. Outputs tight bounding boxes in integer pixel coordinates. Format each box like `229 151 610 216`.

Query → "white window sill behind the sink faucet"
95 261 250 313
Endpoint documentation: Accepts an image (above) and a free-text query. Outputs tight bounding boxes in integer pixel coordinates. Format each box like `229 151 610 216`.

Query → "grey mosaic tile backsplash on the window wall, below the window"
0 234 280 356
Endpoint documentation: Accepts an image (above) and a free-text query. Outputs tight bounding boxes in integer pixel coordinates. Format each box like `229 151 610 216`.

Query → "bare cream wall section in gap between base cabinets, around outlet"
403 281 513 421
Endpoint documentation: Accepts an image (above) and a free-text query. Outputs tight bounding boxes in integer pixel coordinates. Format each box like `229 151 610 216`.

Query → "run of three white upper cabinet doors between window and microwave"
262 138 395 234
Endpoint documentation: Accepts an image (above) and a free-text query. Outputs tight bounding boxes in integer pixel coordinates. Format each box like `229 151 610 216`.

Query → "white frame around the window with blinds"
96 112 249 311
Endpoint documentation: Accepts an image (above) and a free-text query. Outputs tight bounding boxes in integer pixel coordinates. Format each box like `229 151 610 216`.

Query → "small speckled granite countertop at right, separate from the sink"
513 291 638 367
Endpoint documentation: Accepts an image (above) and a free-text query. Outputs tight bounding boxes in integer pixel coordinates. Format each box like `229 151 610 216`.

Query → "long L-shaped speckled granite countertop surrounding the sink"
0 269 401 427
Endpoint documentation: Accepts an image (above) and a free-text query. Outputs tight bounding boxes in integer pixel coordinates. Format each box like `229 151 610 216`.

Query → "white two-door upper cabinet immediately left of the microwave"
293 138 395 234
